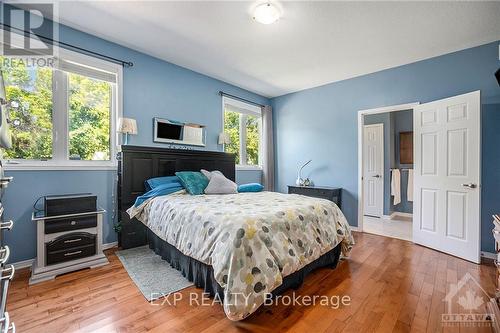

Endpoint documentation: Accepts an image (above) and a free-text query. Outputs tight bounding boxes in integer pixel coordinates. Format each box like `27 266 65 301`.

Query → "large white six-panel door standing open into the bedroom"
413 91 481 263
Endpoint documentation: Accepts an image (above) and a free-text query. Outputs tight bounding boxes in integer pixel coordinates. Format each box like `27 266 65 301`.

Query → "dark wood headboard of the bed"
117 145 235 248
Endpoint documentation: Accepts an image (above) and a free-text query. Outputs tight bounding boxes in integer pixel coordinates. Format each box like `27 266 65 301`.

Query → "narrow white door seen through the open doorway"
363 124 384 217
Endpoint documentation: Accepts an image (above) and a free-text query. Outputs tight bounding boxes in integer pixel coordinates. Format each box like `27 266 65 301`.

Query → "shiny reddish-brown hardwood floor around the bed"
7 233 495 333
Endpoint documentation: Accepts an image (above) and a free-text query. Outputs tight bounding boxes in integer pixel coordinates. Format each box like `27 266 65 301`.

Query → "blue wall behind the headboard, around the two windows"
4 14 270 262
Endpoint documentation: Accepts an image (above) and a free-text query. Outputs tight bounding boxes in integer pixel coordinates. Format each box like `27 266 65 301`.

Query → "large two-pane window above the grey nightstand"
0 39 121 168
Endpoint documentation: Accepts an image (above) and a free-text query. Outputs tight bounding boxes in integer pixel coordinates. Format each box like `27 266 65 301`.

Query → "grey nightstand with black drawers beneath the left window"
29 209 108 284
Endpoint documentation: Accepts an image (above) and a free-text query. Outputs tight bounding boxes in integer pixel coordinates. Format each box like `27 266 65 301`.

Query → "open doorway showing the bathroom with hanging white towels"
362 106 413 241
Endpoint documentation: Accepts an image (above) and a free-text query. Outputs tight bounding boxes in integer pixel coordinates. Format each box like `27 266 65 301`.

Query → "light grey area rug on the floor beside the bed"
116 245 193 301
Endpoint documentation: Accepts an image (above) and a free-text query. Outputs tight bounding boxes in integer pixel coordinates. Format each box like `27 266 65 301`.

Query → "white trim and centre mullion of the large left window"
0 29 123 170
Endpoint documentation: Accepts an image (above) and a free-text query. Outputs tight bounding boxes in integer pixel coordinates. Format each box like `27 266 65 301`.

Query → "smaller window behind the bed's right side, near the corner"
223 97 262 167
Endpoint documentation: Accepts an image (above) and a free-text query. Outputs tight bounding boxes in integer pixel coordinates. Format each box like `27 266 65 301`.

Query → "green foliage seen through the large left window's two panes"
0 57 112 160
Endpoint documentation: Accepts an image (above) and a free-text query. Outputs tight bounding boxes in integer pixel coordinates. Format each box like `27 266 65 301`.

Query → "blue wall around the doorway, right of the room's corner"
272 42 500 252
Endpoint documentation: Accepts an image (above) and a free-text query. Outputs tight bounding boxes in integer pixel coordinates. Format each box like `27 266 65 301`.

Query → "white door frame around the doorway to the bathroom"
356 102 420 231
